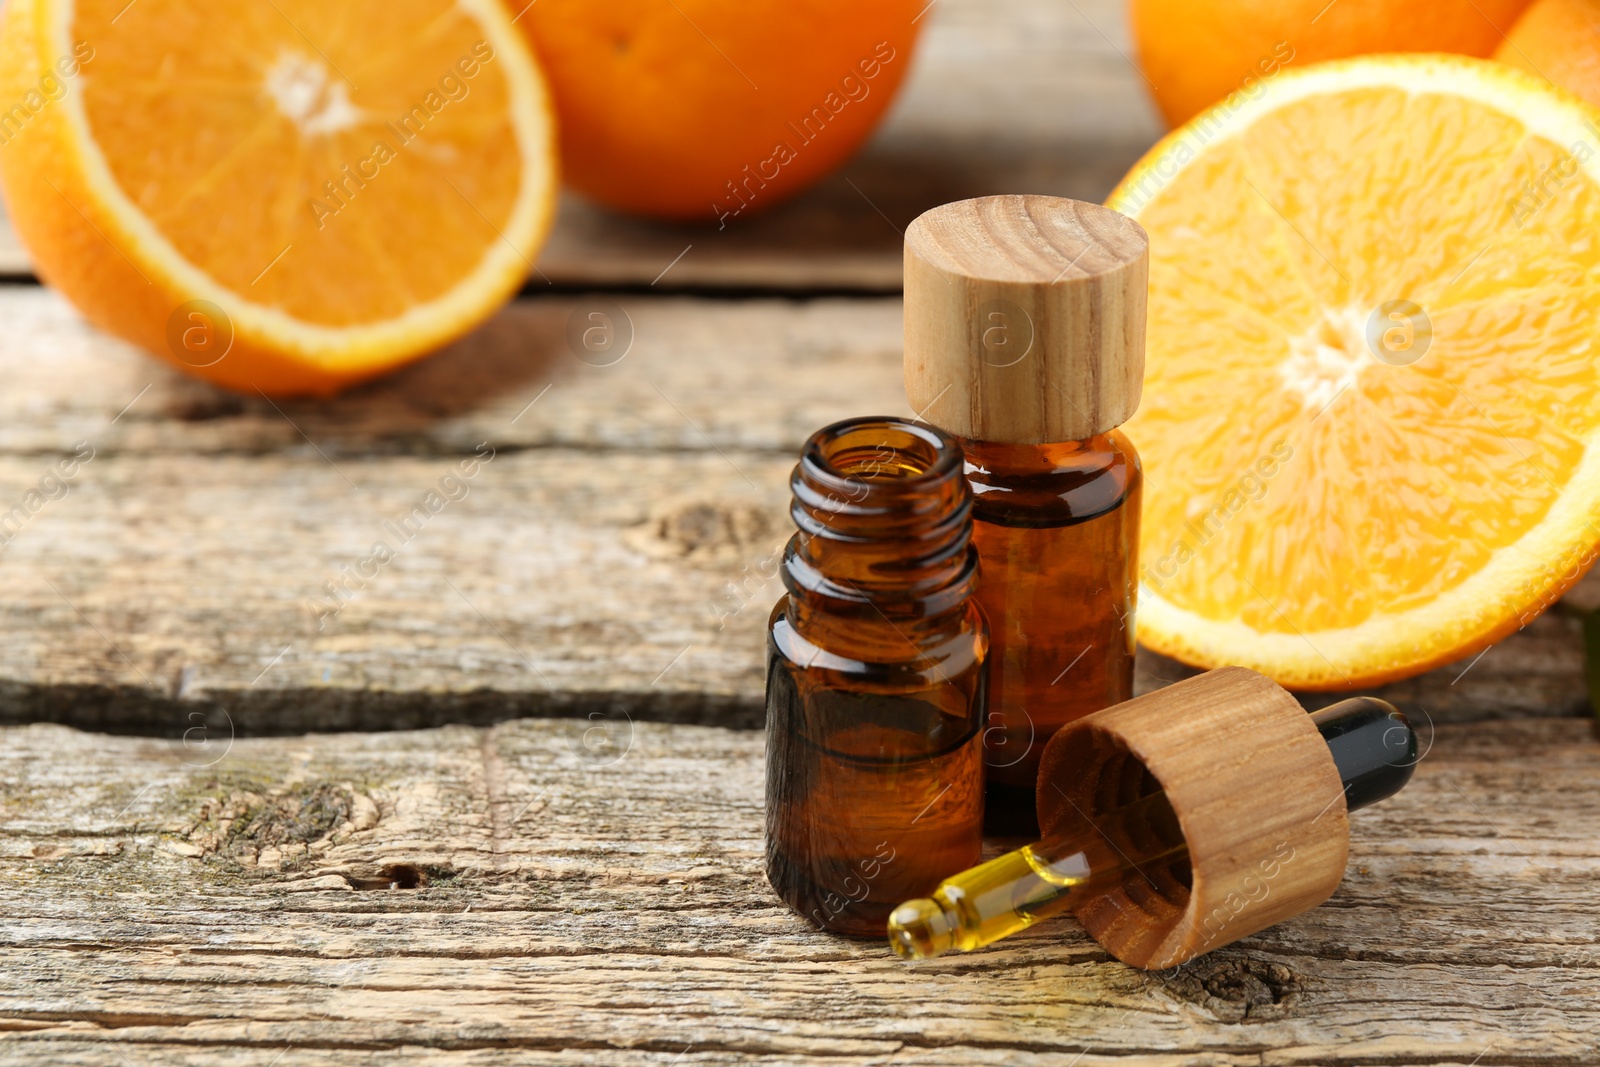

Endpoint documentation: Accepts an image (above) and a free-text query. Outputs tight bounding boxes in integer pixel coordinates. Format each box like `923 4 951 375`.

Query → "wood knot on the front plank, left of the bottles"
178 782 378 870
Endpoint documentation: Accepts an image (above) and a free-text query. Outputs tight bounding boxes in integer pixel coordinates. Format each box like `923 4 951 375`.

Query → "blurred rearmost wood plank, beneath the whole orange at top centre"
0 0 1160 291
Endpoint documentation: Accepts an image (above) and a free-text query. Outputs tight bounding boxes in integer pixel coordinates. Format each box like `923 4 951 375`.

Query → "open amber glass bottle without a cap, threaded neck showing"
766 419 989 937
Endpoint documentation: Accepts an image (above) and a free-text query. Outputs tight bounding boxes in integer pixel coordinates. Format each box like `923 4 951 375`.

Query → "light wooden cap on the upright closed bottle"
906 197 1149 445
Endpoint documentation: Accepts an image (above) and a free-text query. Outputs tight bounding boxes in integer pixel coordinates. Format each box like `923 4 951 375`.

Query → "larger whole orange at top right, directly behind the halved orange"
1130 0 1530 126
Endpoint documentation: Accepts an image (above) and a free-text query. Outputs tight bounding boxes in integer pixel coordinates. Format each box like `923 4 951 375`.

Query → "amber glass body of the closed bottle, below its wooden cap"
962 430 1141 835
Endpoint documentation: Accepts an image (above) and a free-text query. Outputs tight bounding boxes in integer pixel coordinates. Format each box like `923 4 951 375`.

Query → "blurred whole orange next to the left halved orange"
524 0 926 224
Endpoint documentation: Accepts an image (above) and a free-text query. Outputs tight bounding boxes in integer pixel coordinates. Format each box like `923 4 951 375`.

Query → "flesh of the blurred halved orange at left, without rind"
70 0 522 326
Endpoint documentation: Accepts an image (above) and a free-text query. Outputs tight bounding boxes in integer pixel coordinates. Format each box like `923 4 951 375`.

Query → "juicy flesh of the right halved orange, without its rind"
1114 88 1600 633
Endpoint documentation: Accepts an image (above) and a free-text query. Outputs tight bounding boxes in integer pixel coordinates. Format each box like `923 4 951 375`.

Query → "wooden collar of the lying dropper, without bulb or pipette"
1038 667 1350 969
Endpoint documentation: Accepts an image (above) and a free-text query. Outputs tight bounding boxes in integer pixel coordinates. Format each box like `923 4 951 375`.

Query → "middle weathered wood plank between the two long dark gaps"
0 286 1592 733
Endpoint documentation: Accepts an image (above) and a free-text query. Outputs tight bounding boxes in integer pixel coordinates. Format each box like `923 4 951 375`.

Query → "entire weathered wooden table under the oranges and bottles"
0 0 1600 1067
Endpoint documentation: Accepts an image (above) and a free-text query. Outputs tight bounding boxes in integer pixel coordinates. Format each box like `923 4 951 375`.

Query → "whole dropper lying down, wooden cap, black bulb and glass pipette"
888 667 1418 969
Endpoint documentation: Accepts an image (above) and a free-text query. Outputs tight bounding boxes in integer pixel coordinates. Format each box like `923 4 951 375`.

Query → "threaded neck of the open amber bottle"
784 418 978 624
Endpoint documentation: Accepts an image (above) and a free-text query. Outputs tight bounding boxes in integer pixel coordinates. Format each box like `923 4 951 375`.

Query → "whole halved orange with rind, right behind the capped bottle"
1109 56 1600 689
